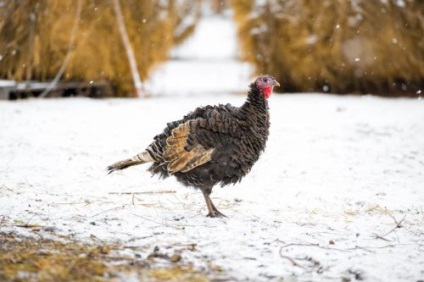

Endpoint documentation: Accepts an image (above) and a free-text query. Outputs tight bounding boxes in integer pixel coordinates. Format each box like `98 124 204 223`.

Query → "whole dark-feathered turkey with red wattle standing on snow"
107 75 280 217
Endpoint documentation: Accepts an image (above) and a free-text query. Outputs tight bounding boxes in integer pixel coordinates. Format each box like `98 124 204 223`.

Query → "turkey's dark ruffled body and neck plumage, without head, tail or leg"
147 84 270 194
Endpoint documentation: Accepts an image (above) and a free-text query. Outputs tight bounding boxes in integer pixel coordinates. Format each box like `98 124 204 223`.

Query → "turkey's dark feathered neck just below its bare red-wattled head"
241 83 269 123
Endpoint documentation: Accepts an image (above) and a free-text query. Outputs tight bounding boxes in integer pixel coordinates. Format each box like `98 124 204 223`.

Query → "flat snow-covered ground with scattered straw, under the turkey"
0 94 424 281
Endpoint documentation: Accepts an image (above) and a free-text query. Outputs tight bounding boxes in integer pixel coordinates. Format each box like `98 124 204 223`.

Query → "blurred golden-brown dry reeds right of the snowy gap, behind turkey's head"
232 0 424 96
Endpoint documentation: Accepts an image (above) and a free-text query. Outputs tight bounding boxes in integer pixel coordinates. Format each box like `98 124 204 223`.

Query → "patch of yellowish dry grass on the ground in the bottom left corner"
0 233 208 282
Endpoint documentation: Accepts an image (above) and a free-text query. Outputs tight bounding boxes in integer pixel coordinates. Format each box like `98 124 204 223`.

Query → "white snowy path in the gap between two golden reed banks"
146 14 252 97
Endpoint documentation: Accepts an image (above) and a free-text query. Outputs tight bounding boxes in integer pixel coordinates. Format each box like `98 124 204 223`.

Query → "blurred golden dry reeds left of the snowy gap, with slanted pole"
0 0 199 96
